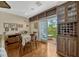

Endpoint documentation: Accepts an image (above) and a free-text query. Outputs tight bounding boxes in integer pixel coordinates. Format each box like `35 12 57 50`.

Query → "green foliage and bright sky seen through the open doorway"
48 16 57 38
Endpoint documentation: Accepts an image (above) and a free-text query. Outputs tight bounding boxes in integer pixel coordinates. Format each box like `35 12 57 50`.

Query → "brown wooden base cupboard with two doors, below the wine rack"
57 36 77 56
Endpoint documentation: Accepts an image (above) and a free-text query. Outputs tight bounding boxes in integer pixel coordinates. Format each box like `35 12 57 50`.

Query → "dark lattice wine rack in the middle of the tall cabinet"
59 22 77 36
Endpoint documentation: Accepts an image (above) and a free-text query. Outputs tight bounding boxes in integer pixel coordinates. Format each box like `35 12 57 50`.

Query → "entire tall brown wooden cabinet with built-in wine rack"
57 1 79 57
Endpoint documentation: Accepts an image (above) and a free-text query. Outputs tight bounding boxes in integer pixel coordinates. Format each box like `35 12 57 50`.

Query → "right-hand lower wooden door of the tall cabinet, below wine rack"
66 37 77 56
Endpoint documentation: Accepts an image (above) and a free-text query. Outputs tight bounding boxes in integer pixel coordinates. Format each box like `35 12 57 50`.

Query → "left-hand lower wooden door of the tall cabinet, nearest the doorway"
57 37 66 56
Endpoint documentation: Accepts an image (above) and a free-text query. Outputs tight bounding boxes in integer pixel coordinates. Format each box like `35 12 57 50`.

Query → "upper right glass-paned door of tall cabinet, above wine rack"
66 2 77 22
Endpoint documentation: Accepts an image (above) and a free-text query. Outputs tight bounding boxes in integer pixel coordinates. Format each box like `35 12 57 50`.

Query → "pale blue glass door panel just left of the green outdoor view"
39 18 48 42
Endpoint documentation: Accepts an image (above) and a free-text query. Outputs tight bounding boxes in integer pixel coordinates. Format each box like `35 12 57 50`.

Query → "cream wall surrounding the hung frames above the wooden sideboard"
0 12 29 46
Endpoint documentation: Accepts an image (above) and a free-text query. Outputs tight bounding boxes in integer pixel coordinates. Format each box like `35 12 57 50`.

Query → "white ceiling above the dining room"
0 1 66 18
